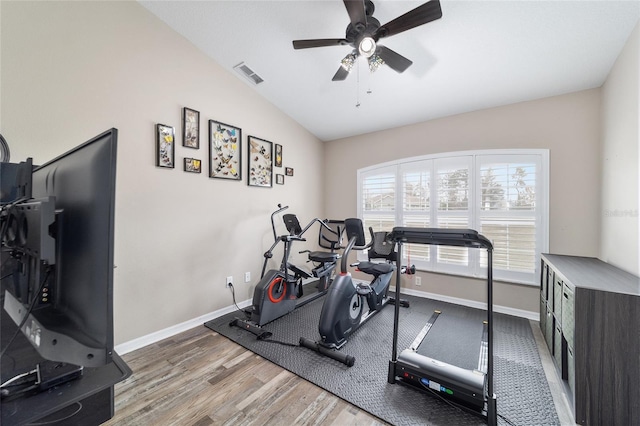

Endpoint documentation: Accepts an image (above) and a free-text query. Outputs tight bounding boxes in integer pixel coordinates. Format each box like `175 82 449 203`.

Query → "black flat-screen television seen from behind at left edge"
2 129 118 367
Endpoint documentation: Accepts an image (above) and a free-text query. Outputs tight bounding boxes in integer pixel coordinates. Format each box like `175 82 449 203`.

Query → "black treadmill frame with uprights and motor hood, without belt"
387 227 498 426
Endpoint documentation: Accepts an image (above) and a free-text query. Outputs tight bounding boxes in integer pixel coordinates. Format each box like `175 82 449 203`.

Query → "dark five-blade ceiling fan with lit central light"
293 0 442 81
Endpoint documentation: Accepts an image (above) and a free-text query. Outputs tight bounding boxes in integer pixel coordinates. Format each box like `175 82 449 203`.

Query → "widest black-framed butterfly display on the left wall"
209 120 242 180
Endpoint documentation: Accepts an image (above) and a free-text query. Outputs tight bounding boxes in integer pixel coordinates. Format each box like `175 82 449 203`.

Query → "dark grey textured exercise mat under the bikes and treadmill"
205 296 559 425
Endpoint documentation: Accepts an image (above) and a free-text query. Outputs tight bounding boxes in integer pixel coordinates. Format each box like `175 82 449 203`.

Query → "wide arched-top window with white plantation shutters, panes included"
358 150 549 284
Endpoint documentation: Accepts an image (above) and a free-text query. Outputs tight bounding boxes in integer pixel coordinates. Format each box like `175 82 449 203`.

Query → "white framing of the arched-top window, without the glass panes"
357 149 549 286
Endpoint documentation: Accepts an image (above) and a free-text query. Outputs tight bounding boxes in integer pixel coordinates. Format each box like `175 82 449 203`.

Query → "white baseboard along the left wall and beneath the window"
115 287 540 355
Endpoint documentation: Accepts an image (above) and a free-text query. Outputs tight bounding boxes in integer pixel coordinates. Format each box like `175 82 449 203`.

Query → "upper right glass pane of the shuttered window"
480 163 536 211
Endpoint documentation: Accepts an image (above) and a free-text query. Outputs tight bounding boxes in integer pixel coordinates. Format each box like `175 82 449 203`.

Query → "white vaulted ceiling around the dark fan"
140 0 640 141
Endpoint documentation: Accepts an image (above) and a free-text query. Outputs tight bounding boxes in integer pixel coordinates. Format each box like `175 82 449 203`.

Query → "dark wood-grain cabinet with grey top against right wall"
540 254 640 426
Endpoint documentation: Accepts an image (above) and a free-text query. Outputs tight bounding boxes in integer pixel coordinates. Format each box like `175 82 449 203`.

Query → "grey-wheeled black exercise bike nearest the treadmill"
299 218 409 367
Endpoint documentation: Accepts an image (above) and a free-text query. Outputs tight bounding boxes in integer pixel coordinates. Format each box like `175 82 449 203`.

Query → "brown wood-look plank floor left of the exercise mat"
105 326 386 426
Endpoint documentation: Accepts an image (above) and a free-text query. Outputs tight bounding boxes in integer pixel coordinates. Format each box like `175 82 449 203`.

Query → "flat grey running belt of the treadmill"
416 309 486 370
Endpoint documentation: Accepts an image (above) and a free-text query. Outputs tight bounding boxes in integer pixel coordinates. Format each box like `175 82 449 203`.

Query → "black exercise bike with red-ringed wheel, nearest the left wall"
229 204 342 339
